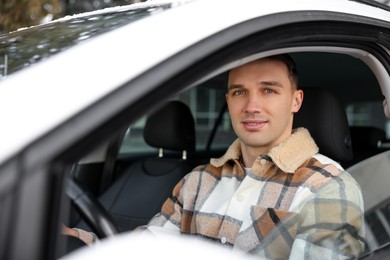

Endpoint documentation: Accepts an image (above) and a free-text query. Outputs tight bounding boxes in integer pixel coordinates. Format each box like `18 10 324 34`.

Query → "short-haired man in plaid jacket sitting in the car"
68 55 364 259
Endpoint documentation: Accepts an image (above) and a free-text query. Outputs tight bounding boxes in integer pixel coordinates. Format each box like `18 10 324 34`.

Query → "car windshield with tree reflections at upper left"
0 4 172 80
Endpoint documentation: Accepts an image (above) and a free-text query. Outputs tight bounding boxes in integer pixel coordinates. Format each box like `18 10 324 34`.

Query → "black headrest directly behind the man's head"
294 88 353 162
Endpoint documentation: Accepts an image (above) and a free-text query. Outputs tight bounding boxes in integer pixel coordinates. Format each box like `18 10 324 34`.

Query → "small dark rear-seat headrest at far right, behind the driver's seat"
350 126 386 149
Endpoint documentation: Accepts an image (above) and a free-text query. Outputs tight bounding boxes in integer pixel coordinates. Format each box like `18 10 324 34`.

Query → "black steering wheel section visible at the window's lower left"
67 178 118 238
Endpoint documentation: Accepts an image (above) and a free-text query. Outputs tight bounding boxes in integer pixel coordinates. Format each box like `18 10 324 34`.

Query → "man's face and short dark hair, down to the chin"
226 59 303 153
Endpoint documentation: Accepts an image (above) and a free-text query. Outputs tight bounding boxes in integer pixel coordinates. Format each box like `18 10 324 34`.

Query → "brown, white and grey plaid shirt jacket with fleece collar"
145 128 364 259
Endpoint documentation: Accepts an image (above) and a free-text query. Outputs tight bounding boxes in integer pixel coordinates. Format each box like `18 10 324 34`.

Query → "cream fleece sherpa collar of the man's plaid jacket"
210 127 319 173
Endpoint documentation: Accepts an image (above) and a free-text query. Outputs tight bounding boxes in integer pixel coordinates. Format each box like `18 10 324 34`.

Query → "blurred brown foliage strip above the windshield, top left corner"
0 0 145 34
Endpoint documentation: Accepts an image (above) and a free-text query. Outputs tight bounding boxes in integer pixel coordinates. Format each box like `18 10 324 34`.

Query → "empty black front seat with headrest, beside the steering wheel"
78 101 195 232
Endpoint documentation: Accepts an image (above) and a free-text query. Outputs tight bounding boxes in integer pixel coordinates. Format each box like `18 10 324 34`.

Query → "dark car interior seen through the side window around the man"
64 47 390 259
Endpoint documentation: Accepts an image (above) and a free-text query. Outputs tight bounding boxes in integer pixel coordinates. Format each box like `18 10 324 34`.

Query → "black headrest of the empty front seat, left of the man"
144 101 195 152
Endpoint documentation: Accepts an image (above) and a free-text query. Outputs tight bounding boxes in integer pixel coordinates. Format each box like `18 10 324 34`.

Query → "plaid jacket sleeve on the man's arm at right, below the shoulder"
290 172 365 259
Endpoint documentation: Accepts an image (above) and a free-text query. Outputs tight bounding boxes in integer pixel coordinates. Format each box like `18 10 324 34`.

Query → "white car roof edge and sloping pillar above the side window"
0 0 389 163
